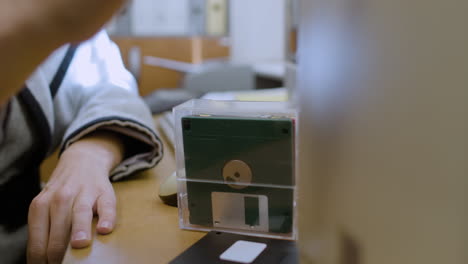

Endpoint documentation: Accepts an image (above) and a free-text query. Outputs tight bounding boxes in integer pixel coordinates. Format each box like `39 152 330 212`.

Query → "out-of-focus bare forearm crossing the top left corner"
0 0 124 104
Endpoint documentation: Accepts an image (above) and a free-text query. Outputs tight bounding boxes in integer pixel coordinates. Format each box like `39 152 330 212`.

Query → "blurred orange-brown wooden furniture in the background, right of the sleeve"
112 36 230 96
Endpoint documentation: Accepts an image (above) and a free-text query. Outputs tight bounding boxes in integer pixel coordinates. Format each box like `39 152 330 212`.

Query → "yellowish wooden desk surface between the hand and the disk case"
63 120 204 264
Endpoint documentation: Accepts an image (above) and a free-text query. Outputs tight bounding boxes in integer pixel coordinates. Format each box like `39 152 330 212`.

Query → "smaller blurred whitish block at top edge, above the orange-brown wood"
131 0 190 36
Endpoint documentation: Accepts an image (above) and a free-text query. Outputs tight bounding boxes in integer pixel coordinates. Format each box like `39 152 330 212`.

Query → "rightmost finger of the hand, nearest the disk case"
96 192 116 235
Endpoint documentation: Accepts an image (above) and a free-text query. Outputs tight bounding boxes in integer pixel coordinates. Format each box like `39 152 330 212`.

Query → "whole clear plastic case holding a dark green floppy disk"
174 100 297 240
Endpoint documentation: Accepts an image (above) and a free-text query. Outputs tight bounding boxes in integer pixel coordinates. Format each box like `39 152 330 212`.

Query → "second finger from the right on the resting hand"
70 195 94 248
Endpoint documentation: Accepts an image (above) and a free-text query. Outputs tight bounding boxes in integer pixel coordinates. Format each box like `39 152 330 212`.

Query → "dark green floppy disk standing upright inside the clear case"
182 116 295 234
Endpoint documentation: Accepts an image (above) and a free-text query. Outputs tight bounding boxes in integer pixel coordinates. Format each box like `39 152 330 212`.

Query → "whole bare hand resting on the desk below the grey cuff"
27 132 123 264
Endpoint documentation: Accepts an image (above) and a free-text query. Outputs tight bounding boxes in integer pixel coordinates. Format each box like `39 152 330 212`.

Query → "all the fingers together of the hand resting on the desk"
27 177 116 264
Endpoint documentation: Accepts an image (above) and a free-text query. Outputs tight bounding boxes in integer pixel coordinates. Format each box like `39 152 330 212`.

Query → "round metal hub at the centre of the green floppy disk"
223 160 252 190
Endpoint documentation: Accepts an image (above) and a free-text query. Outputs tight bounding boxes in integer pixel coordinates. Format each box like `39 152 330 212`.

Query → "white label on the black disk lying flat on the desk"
219 240 267 264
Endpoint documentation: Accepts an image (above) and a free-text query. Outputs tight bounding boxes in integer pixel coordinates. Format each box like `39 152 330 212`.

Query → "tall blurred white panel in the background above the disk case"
230 0 286 63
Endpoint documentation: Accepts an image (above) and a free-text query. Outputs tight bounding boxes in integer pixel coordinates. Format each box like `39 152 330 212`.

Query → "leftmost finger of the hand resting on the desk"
27 193 50 264
